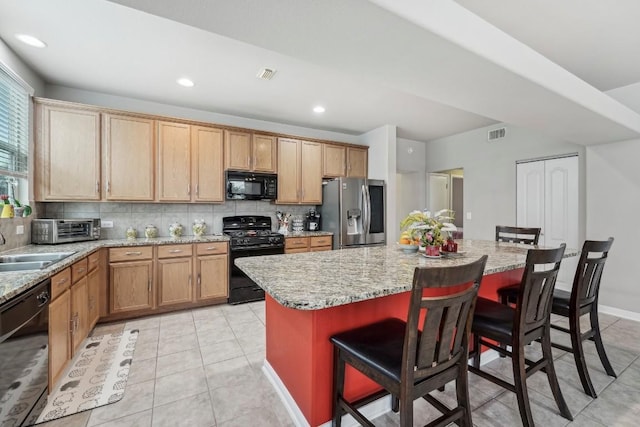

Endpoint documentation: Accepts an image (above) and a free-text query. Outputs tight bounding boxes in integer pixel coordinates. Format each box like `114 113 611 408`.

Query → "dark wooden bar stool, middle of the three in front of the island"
469 243 573 427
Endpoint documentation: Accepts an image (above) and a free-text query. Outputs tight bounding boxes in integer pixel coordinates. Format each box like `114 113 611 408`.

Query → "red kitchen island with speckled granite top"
236 240 577 426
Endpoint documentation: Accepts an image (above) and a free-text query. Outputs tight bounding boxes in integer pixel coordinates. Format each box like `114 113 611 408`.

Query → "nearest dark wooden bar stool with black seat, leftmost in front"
330 255 487 427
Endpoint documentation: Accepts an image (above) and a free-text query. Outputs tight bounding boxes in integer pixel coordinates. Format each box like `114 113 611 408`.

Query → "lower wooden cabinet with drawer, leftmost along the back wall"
109 246 154 314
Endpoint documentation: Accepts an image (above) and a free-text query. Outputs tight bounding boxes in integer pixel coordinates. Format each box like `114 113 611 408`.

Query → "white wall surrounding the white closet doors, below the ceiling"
426 125 585 240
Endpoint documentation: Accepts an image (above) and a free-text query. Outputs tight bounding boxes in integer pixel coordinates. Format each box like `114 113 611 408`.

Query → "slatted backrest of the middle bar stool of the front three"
515 243 566 334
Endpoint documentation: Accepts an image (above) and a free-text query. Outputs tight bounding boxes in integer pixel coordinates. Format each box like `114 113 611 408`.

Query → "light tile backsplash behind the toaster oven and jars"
38 200 315 239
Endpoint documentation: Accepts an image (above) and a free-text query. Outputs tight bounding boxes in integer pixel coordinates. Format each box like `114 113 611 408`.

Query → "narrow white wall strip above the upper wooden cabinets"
44 85 362 144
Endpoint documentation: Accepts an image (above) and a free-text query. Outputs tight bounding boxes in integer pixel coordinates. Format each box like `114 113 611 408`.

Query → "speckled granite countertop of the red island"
235 239 578 310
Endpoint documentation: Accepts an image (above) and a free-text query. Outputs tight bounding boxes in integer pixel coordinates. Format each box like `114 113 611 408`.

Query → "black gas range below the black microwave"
222 216 284 304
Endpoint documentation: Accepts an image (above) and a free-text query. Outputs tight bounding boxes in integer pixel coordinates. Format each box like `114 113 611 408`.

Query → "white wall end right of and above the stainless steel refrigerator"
359 125 398 244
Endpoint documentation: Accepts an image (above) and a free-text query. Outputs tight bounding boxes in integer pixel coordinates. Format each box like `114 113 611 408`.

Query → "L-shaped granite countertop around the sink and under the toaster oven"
0 235 229 304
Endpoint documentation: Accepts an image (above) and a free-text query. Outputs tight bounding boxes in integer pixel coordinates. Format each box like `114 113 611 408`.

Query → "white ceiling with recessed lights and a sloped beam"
0 0 640 144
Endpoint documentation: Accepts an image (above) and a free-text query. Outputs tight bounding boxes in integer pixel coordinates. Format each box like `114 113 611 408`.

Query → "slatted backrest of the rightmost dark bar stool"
571 237 613 308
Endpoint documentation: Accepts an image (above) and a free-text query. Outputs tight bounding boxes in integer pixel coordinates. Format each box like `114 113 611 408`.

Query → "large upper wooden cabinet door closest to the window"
35 105 100 201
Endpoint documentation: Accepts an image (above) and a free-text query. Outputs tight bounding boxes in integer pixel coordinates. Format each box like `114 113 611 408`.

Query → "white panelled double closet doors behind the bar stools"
516 156 580 290
